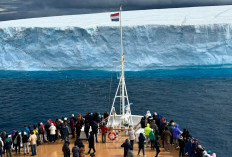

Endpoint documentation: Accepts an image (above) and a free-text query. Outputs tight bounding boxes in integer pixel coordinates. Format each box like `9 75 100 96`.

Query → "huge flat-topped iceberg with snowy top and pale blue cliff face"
0 6 232 70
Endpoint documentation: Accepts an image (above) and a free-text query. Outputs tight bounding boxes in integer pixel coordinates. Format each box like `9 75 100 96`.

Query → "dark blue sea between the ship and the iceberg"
0 68 232 157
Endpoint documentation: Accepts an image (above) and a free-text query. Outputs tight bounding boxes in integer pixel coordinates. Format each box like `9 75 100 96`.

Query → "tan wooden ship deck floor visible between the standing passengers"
10 132 179 157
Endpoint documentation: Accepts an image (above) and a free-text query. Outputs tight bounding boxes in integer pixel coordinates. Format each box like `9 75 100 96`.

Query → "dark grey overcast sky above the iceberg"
0 0 232 21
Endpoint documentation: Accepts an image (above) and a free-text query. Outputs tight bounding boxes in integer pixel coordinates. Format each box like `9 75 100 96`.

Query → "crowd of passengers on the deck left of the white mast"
0 112 109 157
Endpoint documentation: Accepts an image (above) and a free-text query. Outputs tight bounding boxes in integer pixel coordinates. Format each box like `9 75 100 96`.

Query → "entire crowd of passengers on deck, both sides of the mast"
0 111 216 157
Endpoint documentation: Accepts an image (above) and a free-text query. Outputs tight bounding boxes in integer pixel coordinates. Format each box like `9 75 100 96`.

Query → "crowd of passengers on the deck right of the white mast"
121 111 216 157
